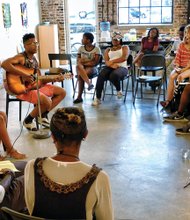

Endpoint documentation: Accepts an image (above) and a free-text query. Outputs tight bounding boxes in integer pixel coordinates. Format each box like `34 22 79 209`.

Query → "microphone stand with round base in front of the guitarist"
32 69 51 139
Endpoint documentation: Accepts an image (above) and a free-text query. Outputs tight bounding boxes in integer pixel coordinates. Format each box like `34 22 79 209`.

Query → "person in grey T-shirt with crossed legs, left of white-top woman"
73 32 101 104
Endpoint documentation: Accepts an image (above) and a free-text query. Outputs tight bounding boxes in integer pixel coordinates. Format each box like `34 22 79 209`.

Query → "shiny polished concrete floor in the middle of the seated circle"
0 78 190 220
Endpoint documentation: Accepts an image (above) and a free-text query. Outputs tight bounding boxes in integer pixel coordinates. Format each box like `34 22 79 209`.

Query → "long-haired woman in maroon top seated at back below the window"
133 28 159 66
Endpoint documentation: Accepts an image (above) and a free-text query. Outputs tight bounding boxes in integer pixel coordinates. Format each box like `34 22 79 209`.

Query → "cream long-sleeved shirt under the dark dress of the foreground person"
24 158 114 220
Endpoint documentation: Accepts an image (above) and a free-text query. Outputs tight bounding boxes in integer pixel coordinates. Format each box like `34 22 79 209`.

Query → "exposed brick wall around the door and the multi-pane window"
40 0 188 52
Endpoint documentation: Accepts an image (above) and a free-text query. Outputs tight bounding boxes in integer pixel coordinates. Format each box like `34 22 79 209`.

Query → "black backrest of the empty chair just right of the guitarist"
48 53 73 73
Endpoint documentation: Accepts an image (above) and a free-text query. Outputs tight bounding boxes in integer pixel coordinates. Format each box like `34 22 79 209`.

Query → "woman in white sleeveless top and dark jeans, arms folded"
92 33 130 106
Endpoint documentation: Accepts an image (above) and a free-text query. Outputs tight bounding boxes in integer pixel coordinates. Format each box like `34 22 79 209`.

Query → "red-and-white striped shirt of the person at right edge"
174 42 190 67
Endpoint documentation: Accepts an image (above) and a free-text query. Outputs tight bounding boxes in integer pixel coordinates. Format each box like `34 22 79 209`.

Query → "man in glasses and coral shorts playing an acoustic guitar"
2 33 66 131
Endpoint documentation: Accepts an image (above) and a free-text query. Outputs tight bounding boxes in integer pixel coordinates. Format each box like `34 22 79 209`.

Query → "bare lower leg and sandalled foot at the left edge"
0 112 26 160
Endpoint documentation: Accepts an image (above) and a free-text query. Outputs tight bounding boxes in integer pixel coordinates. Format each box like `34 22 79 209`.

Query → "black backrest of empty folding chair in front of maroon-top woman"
141 53 166 68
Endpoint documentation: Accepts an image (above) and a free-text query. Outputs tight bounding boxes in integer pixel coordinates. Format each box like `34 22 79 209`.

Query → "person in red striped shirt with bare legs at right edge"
160 25 190 108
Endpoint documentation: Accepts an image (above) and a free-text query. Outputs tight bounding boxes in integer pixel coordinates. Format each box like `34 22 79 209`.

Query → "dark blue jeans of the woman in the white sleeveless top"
96 66 128 99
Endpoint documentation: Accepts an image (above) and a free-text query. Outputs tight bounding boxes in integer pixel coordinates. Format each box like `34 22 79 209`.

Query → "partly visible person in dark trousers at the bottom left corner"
0 161 26 219
